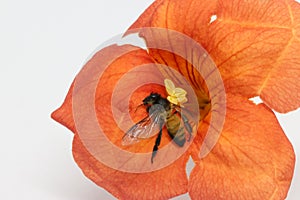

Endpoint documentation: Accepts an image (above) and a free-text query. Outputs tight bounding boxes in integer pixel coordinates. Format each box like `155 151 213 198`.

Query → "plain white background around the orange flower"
0 0 300 200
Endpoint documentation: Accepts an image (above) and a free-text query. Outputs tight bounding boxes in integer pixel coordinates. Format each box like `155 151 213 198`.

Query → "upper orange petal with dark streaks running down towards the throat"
129 0 217 100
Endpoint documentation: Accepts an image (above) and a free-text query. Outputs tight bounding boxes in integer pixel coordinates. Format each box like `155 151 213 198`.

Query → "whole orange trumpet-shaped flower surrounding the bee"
52 0 300 199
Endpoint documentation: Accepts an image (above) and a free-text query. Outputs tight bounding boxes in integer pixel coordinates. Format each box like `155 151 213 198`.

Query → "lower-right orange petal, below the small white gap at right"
189 95 295 199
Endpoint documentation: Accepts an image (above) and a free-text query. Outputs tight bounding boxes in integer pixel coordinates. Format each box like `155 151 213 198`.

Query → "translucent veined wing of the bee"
122 110 165 145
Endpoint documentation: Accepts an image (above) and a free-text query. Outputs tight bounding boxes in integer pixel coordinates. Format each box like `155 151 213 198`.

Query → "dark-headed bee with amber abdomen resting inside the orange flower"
122 90 192 163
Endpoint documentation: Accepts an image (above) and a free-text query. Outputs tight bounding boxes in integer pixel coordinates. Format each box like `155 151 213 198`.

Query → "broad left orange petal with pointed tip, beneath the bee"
52 45 188 199
